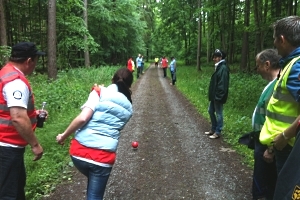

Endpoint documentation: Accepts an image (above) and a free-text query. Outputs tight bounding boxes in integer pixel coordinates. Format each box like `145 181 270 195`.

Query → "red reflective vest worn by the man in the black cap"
0 63 36 146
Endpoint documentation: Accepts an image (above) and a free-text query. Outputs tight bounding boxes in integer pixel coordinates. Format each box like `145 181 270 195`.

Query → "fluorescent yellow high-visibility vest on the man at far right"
259 56 300 146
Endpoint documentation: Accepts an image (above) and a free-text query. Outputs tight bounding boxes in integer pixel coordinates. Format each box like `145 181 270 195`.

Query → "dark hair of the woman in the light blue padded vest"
112 68 133 103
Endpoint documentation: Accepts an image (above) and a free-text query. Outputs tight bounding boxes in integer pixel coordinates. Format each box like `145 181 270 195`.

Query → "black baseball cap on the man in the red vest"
11 42 46 58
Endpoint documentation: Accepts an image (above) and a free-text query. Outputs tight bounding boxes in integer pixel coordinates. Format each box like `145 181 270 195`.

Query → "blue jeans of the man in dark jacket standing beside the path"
208 101 223 135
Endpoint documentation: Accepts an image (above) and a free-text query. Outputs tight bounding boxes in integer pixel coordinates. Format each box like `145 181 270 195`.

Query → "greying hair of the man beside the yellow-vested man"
256 49 281 69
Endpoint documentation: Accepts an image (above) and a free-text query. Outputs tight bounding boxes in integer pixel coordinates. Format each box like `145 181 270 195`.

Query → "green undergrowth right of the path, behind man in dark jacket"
176 65 266 167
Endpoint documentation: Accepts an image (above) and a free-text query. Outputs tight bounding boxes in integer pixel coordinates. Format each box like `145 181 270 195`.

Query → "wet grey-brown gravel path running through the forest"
43 65 252 200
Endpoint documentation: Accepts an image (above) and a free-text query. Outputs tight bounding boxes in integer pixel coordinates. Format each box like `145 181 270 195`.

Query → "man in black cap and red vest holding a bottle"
0 42 45 200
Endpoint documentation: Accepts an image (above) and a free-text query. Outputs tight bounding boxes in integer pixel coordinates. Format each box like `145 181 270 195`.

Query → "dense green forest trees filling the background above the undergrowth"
0 0 299 79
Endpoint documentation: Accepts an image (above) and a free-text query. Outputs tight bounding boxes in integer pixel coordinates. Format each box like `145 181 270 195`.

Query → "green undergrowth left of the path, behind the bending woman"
25 67 125 199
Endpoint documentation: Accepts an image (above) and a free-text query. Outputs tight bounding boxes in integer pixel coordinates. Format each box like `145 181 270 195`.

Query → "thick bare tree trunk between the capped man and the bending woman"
48 0 57 79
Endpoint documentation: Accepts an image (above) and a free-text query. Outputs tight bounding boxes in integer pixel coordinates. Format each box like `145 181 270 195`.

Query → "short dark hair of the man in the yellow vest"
273 16 300 47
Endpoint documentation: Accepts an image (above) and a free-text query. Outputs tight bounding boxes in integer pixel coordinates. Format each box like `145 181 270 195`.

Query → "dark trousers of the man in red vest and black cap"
0 146 26 200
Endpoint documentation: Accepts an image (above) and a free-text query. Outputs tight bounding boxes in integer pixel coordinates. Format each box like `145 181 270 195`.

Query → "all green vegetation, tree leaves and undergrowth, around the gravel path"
0 0 299 199
